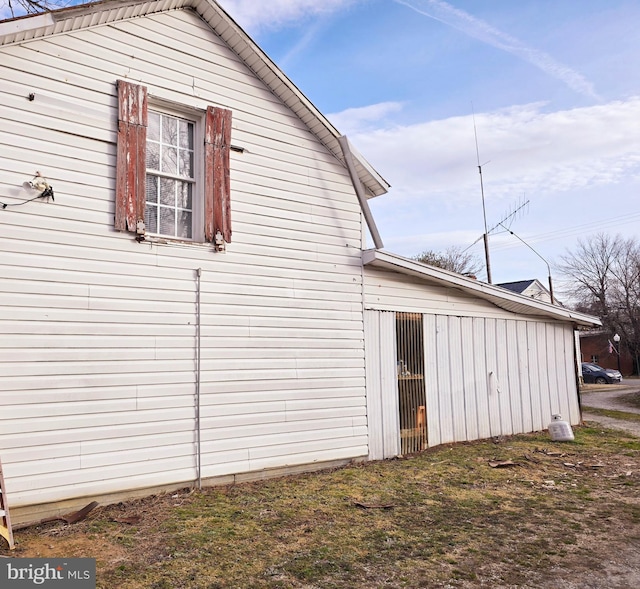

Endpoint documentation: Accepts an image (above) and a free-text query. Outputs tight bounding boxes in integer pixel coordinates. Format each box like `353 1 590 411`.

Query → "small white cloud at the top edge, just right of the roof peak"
219 0 358 33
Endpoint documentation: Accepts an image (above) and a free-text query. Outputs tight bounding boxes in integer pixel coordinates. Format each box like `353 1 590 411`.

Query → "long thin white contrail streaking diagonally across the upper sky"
394 0 601 101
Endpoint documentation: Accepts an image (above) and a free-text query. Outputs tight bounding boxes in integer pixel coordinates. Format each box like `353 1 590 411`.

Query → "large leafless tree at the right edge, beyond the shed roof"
557 233 640 372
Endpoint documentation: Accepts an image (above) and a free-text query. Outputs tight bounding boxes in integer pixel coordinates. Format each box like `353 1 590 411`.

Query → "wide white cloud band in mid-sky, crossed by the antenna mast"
348 97 640 207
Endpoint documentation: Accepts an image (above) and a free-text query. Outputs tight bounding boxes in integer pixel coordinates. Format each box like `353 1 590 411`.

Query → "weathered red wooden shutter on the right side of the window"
204 106 231 243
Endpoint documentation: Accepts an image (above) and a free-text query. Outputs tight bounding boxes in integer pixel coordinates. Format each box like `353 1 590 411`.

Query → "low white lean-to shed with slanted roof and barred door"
363 250 597 459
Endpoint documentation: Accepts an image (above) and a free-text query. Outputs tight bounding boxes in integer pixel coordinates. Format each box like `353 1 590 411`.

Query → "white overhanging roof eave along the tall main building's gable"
0 0 390 196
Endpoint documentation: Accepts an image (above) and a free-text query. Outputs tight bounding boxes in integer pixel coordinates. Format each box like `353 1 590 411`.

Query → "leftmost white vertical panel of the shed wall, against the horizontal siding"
364 311 384 460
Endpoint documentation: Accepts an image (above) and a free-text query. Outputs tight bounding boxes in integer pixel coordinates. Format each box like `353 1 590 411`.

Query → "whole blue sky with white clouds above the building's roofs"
220 0 640 283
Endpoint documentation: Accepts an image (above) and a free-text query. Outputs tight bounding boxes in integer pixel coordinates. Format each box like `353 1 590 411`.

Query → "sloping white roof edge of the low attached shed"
362 249 602 327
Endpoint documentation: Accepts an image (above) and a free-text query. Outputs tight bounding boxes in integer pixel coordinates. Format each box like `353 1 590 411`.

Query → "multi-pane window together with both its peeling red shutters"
115 80 231 249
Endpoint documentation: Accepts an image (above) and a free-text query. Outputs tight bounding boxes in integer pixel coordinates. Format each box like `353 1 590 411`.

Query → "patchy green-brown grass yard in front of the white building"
2 427 640 589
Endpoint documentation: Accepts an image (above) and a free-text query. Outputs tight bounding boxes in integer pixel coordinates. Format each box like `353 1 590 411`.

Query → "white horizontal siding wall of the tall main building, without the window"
0 6 368 507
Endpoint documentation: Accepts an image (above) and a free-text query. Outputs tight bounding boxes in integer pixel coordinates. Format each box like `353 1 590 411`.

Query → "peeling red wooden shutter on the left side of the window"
115 80 147 233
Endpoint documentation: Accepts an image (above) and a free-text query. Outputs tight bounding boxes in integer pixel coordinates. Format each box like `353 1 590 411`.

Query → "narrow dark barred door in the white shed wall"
396 313 427 454
